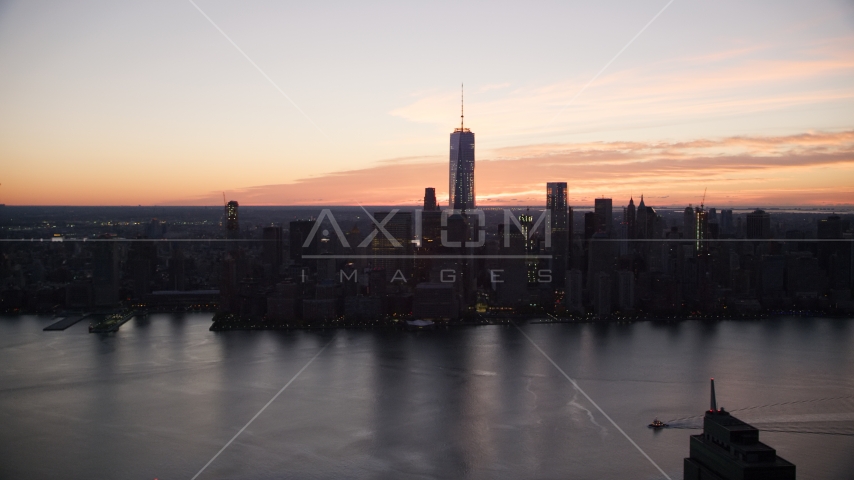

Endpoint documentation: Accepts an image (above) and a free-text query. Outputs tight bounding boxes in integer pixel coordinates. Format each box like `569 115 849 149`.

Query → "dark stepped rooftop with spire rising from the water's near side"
684 378 795 480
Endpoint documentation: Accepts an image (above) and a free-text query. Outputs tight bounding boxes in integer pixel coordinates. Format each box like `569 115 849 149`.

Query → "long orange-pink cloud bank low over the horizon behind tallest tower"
169 130 854 206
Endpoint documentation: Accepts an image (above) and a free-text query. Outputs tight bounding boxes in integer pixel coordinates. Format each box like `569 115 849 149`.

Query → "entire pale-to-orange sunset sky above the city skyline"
0 0 854 207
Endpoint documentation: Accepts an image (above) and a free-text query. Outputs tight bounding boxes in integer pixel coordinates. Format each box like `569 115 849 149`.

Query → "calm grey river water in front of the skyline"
0 314 854 480
